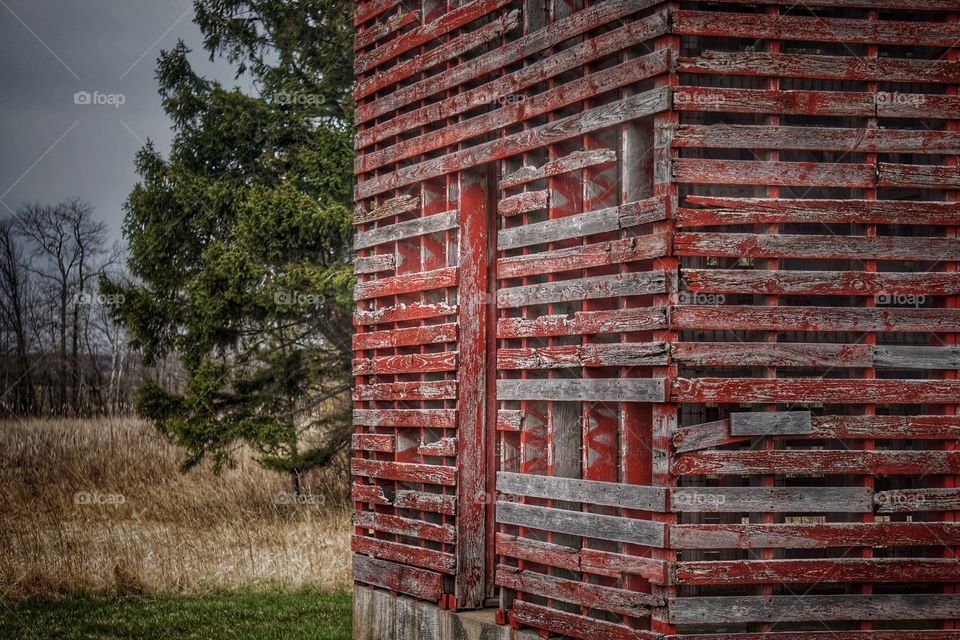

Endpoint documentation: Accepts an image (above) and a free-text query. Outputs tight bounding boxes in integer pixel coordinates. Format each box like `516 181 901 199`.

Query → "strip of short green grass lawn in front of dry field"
0 591 350 640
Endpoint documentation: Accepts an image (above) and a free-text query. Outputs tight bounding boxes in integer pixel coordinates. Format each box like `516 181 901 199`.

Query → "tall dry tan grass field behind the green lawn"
0 419 351 598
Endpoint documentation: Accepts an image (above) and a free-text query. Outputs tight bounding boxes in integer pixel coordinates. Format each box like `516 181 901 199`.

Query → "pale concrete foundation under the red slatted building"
353 586 538 640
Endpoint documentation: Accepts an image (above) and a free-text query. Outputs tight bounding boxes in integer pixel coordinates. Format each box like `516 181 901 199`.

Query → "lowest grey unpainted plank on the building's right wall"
668 594 960 624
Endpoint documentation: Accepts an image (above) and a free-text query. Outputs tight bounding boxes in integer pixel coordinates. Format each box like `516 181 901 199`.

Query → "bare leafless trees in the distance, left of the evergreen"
0 199 175 417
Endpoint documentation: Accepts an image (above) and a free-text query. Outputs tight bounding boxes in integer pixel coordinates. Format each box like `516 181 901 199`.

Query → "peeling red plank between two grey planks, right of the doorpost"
497 233 671 279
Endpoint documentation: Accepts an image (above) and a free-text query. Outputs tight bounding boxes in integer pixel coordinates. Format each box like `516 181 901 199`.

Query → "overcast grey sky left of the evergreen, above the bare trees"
0 0 244 238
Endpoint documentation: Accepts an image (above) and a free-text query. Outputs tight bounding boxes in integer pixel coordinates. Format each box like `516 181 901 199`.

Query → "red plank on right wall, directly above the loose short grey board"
672 378 960 404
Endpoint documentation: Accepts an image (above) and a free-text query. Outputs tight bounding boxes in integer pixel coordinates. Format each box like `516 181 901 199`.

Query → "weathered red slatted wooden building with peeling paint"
352 0 960 640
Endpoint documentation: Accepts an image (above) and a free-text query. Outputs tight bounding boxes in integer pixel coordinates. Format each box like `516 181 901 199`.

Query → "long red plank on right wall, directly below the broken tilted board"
673 450 960 476
